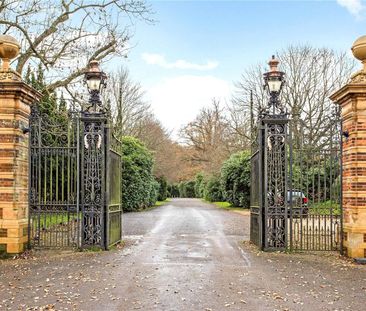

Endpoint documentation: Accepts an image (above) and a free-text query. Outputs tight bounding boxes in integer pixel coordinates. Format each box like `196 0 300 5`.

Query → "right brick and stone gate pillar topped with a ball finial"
330 36 366 258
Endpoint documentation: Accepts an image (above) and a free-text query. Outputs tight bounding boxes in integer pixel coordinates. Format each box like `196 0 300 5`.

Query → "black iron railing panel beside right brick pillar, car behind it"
289 118 343 252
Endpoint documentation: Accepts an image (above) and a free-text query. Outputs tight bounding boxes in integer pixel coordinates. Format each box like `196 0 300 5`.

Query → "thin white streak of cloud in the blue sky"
141 53 219 71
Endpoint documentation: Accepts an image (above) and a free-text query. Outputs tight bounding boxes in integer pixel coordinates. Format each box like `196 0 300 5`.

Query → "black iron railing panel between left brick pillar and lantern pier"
28 106 80 247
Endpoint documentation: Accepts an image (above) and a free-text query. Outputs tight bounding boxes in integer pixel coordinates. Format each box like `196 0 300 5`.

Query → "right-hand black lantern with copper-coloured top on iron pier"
263 55 285 114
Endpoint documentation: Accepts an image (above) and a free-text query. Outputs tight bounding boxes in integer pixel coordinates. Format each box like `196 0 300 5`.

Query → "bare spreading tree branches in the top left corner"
0 0 151 92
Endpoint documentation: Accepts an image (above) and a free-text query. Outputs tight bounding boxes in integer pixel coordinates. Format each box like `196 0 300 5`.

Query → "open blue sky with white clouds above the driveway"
111 0 366 133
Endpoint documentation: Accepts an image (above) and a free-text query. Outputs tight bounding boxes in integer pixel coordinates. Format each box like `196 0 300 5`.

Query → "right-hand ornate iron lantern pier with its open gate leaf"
251 114 288 250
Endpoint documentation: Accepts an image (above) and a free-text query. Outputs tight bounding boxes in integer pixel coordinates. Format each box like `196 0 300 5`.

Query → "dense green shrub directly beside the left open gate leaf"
122 137 159 211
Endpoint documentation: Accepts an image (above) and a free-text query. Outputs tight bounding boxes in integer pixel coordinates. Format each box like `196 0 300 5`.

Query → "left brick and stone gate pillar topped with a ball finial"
0 36 40 253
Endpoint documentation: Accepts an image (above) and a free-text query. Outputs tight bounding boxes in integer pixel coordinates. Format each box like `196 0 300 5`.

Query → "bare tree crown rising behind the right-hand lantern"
230 45 355 149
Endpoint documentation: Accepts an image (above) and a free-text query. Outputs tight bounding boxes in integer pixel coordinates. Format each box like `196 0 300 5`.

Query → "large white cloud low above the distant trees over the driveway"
147 75 232 138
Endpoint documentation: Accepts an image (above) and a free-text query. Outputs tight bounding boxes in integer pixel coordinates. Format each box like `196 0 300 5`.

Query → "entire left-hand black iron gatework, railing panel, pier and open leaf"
29 106 122 248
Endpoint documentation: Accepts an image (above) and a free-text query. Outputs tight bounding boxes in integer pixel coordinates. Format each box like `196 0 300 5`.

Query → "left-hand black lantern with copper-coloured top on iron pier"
84 60 107 112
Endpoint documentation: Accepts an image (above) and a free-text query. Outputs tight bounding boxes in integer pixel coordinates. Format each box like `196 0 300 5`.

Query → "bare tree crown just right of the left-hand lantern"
103 67 152 137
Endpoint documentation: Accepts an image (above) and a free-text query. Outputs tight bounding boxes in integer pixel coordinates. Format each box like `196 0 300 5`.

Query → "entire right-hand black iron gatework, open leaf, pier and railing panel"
250 115 342 251
